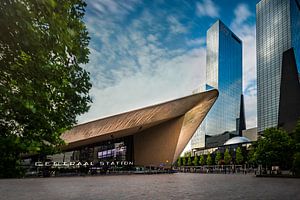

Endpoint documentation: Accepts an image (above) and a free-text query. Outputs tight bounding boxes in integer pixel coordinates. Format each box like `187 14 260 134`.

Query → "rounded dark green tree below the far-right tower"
250 128 293 168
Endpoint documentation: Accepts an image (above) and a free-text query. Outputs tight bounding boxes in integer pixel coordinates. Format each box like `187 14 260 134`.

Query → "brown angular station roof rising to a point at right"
62 90 218 165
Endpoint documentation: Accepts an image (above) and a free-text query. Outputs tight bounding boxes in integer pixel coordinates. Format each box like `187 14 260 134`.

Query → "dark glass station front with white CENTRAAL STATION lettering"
23 136 134 175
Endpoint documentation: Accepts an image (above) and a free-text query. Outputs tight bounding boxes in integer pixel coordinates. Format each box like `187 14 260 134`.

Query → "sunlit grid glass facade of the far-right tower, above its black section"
256 0 300 132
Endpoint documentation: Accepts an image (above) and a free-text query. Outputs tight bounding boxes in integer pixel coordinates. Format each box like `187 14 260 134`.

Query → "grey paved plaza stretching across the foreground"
0 173 300 200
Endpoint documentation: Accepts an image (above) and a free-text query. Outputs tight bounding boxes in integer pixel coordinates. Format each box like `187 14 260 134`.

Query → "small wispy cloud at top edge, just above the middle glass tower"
196 0 220 18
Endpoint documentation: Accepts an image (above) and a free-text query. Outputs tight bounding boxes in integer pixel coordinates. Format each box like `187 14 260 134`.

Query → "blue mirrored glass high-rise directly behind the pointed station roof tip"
191 20 242 148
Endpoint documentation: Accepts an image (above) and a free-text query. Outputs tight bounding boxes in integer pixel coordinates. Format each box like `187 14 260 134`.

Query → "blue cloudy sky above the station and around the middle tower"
78 0 257 128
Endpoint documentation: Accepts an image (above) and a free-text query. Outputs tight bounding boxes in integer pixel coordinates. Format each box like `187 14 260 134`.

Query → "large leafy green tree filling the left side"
0 0 91 177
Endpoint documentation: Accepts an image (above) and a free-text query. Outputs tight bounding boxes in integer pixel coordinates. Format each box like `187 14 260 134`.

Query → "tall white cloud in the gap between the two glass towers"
230 4 257 128
